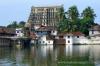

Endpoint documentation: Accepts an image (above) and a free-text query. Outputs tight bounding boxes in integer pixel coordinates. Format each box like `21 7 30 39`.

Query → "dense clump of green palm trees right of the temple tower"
58 6 96 35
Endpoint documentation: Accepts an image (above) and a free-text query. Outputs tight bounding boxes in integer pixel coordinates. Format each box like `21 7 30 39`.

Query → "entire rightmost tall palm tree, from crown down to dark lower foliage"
80 7 96 35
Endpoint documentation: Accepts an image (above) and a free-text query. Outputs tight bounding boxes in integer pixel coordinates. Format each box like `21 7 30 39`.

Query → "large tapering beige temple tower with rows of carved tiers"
26 5 63 27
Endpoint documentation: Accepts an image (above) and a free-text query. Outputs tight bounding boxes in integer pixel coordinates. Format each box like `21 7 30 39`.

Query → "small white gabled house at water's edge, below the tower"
38 35 54 45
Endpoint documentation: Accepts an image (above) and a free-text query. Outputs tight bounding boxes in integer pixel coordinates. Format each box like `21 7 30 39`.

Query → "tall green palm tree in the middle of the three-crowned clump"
66 6 80 32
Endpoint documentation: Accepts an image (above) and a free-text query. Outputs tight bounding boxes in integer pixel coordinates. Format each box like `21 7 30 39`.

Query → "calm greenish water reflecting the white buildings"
0 45 100 66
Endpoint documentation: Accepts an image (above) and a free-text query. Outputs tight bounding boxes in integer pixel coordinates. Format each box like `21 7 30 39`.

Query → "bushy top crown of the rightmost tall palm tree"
81 7 96 27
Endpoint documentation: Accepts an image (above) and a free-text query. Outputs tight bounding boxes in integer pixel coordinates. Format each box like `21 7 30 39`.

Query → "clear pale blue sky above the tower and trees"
0 0 100 26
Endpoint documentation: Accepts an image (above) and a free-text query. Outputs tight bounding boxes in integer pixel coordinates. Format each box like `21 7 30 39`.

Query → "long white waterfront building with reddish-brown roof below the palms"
55 32 90 45
